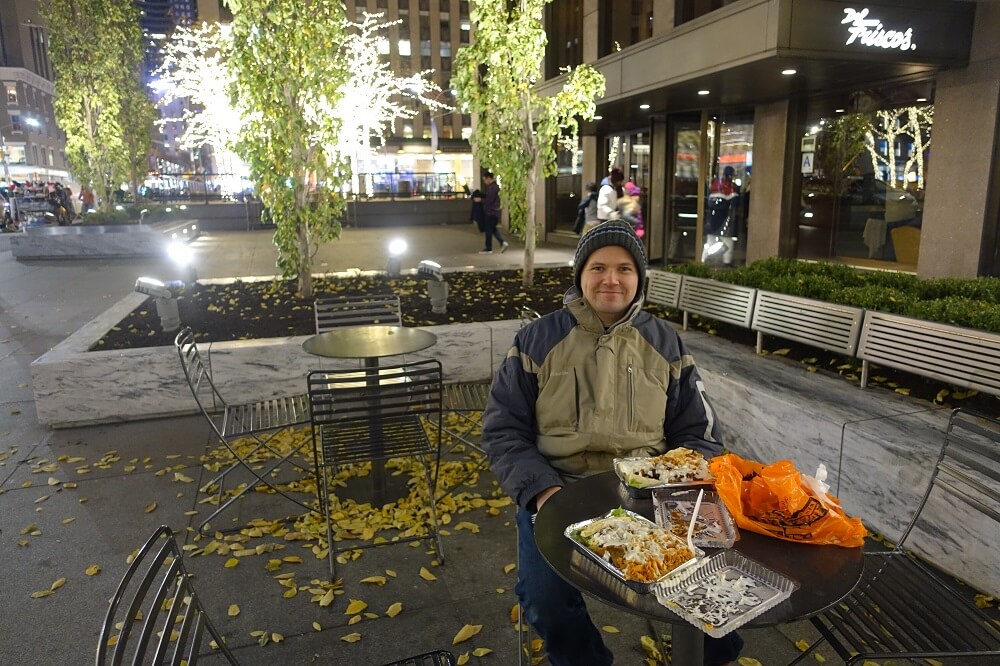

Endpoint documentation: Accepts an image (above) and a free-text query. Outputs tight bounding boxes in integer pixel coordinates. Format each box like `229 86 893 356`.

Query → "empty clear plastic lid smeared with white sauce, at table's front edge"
653 550 798 638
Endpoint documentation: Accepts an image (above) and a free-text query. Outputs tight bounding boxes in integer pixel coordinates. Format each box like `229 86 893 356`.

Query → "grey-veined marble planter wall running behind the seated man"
31 294 1000 594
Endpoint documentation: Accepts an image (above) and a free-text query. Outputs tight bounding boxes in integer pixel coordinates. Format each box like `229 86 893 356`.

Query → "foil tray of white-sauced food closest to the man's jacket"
614 447 715 498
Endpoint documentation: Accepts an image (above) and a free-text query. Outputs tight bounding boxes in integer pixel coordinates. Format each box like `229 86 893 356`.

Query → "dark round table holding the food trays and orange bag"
535 472 864 664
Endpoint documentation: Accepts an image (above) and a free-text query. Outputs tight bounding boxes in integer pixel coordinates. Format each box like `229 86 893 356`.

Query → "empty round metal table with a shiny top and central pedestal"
302 324 437 502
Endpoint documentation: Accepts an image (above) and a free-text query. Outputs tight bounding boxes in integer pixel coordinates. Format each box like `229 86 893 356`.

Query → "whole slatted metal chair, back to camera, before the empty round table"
307 359 444 578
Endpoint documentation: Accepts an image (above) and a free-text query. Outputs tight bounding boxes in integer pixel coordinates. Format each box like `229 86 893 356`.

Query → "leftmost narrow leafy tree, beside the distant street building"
41 0 151 210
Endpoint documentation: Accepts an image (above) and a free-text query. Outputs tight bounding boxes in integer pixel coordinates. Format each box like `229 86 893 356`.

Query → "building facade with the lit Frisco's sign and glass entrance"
537 0 1000 277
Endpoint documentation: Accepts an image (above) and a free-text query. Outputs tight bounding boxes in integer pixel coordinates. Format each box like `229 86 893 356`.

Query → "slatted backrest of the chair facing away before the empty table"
306 359 442 464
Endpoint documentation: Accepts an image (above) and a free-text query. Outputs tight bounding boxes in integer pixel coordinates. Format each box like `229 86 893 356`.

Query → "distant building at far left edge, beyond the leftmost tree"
0 0 69 182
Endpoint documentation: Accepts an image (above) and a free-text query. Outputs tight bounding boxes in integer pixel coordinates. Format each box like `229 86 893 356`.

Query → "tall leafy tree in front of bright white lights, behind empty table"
228 0 350 298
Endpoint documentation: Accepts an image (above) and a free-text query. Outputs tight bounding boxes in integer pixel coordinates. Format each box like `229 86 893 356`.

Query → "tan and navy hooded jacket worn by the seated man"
482 288 722 509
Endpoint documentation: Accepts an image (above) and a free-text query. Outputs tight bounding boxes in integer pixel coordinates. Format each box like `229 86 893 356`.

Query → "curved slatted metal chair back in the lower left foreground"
95 525 239 666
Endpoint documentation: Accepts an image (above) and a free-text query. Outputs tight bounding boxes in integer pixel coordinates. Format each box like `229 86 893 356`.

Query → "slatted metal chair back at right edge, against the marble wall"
896 407 1000 550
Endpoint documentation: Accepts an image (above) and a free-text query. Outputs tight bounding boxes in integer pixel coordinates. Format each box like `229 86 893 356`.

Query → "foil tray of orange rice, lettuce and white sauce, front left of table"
563 508 705 594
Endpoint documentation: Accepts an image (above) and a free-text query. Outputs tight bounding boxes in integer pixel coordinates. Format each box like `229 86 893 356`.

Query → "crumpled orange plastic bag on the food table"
708 453 867 548
